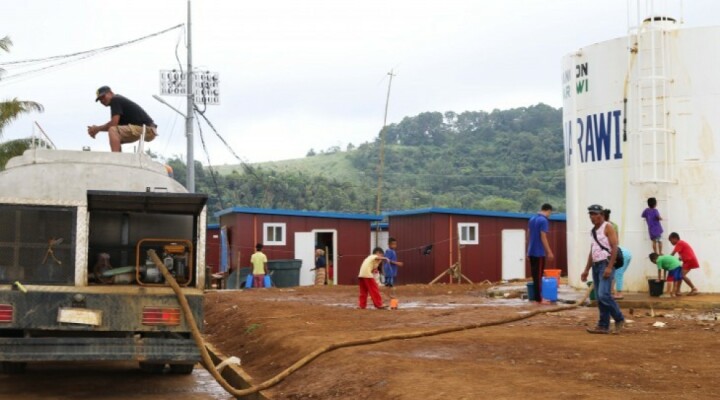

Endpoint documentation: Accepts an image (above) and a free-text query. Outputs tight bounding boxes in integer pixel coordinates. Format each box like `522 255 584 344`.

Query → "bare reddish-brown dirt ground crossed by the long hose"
205 285 720 400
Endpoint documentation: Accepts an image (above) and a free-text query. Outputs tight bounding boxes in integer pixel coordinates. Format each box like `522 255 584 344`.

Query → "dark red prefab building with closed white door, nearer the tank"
383 208 567 284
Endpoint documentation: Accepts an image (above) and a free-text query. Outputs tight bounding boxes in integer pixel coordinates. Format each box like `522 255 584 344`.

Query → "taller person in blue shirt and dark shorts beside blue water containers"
528 203 555 303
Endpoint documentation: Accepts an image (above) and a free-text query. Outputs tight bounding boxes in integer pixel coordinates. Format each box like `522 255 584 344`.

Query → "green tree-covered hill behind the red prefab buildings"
169 104 565 220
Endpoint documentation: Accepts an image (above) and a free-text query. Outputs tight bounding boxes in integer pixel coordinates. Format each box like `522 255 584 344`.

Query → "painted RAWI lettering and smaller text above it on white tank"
562 62 622 166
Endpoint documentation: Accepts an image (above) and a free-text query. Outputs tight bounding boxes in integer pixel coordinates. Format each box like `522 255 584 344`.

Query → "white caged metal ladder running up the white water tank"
628 10 676 183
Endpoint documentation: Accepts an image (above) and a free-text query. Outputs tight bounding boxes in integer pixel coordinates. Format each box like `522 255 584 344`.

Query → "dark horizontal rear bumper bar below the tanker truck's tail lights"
0 335 200 363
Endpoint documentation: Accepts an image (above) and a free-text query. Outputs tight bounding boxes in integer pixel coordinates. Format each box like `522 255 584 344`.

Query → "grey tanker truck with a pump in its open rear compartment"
0 149 207 374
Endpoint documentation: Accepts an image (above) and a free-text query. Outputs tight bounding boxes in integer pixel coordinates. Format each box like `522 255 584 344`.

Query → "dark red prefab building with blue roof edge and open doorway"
216 207 382 285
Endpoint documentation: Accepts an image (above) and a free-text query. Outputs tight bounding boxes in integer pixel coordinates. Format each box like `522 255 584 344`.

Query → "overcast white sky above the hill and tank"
0 0 720 164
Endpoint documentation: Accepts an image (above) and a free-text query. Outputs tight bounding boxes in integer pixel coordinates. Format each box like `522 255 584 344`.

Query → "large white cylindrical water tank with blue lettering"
562 7 720 292
